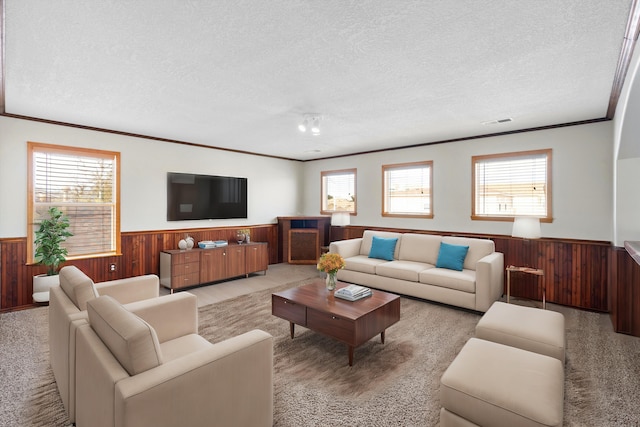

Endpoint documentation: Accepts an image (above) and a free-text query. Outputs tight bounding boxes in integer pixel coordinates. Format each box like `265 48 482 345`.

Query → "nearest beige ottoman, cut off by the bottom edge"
440 338 564 427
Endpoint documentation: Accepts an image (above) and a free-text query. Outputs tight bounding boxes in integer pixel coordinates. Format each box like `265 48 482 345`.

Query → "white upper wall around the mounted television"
0 117 303 238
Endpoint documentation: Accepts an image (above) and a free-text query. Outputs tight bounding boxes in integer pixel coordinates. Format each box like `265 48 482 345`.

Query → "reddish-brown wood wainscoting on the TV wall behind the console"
0 224 278 311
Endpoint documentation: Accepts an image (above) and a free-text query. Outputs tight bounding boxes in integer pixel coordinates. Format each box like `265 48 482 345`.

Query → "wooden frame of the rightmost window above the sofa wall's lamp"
471 148 553 222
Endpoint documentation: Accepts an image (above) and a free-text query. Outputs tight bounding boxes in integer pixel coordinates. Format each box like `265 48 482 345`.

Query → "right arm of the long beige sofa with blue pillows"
476 252 504 311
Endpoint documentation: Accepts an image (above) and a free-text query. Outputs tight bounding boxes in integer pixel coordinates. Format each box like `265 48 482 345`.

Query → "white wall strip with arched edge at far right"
613 44 640 246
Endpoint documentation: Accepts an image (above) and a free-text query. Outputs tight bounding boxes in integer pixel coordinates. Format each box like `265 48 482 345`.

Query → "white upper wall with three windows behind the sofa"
303 122 613 241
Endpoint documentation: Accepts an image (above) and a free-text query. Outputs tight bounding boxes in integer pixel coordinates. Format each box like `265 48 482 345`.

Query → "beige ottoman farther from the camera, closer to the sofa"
476 301 565 364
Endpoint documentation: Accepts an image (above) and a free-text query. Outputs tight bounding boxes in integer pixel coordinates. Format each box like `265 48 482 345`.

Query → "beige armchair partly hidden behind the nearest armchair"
49 266 160 422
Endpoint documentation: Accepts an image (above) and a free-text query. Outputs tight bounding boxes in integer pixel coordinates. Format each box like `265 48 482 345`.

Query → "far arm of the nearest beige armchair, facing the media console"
125 292 198 343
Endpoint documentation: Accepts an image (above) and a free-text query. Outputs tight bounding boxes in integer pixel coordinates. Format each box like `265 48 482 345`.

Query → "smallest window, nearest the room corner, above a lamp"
320 169 357 214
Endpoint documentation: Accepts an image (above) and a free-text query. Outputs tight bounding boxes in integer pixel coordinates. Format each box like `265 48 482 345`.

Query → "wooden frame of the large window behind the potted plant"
27 141 122 264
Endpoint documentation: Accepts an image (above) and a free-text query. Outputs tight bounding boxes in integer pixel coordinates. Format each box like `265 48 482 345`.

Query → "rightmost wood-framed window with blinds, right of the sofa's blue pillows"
471 149 552 222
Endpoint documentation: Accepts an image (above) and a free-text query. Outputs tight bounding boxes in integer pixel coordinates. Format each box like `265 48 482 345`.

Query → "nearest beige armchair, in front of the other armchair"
76 293 273 427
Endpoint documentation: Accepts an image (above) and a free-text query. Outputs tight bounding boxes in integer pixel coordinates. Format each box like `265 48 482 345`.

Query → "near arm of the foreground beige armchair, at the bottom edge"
115 330 273 427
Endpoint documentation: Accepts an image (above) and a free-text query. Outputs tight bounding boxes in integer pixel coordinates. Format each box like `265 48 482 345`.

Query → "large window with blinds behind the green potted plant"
27 142 120 262
